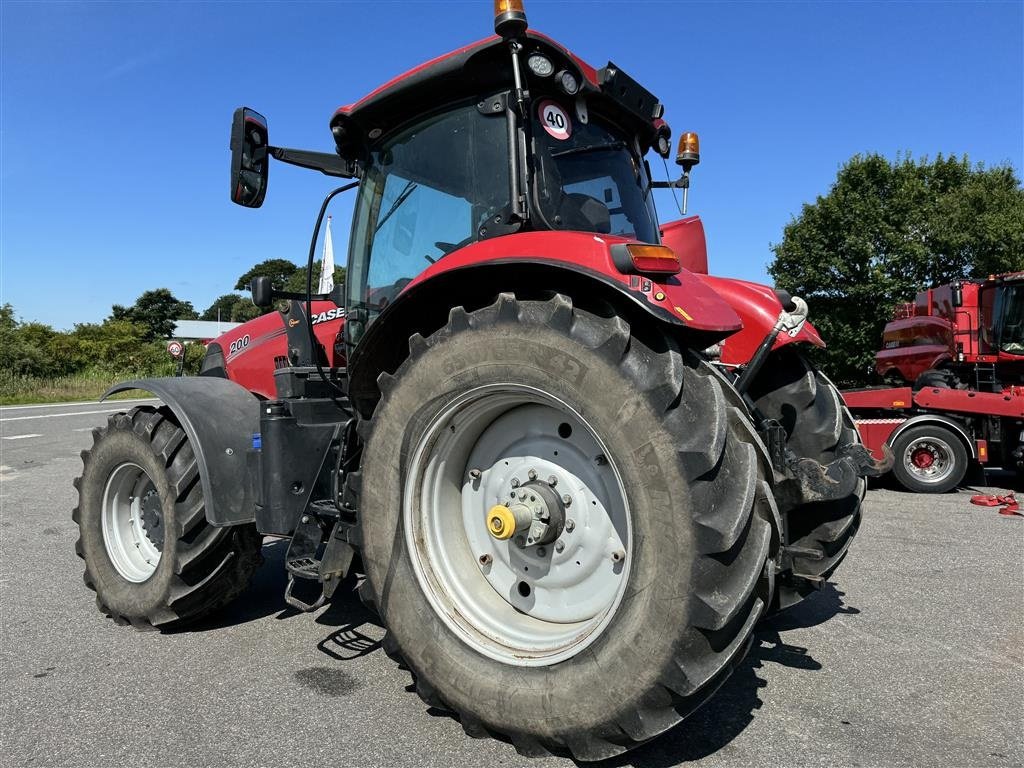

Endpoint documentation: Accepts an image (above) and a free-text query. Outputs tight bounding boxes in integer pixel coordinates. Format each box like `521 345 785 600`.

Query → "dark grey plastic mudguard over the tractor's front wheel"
100 376 259 525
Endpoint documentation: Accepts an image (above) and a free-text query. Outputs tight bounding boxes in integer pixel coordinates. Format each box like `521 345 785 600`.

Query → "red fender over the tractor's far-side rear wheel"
699 274 825 366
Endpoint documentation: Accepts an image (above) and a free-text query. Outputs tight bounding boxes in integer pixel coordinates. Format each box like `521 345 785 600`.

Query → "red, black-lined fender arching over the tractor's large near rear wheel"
348 232 741 415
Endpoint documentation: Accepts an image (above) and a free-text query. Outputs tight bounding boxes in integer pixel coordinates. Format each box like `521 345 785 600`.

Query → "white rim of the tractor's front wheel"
101 462 161 584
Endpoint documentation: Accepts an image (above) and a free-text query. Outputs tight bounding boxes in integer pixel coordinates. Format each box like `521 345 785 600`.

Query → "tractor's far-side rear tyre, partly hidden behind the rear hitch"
750 346 866 610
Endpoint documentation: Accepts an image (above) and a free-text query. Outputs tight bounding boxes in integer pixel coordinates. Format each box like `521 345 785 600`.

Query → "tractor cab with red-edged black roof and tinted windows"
331 33 668 342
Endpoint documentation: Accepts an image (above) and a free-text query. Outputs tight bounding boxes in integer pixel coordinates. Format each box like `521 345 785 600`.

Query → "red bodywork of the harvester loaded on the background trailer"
874 272 1024 382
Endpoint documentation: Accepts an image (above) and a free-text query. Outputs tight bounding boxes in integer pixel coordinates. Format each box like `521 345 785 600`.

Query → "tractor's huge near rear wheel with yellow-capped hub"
360 294 777 760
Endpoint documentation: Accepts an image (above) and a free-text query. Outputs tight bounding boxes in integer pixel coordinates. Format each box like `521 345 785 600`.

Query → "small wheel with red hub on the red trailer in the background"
893 424 968 494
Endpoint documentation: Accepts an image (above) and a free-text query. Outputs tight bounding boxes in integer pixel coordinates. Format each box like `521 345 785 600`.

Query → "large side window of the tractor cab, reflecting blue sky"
347 101 509 334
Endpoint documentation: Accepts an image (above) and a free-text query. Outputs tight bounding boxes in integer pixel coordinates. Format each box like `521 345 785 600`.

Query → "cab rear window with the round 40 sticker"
534 99 658 243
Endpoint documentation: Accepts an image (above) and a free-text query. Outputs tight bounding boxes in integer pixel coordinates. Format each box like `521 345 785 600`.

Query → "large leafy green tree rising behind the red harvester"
768 155 1024 384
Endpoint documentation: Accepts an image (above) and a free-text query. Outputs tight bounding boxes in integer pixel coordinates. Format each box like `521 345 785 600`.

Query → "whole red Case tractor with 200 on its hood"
74 0 879 760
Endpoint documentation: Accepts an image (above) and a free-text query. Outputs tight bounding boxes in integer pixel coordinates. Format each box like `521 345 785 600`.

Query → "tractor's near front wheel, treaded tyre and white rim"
72 408 262 628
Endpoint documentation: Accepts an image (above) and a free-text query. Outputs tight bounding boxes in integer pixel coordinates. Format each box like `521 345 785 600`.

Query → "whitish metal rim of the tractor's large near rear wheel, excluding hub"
402 384 633 667
